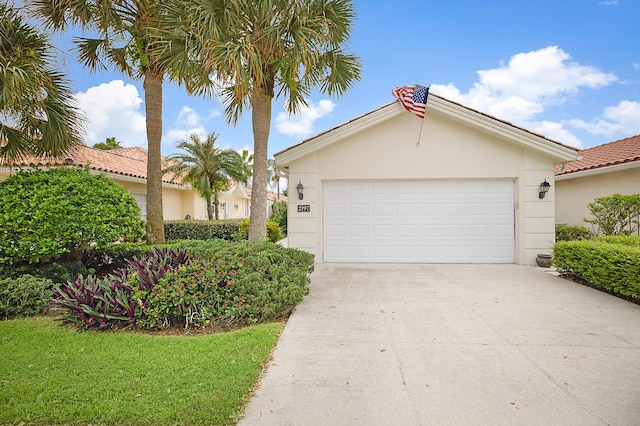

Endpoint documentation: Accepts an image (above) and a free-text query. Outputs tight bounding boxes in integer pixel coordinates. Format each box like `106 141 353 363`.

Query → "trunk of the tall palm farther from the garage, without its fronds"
143 70 165 244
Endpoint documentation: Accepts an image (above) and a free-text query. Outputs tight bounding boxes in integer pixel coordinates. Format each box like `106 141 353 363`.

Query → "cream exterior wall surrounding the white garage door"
284 110 555 264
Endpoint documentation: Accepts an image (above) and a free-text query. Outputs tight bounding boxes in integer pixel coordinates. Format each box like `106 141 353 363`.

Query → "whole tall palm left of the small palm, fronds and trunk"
31 0 192 244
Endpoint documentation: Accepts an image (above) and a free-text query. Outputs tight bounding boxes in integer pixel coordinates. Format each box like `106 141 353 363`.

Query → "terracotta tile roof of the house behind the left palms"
11 145 182 183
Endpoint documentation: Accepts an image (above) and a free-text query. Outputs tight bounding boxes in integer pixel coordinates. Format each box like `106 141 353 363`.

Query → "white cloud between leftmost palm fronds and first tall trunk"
75 80 147 146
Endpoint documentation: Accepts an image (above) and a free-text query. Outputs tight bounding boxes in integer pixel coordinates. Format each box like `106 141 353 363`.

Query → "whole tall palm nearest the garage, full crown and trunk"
160 0 361 241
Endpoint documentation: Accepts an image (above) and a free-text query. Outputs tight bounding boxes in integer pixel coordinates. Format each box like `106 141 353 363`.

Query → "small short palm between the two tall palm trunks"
163 133 251 220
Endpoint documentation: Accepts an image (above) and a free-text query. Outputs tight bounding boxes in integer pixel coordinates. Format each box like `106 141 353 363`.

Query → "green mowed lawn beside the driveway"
0 317 281 425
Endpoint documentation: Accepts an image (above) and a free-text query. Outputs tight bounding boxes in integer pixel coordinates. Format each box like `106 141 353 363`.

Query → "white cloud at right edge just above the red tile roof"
569 100 640 139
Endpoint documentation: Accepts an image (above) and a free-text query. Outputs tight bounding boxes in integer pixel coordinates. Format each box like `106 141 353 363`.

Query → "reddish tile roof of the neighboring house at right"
558 135 640 176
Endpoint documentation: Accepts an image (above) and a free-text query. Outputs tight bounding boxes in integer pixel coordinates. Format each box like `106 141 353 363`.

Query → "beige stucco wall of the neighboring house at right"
556 166 640 226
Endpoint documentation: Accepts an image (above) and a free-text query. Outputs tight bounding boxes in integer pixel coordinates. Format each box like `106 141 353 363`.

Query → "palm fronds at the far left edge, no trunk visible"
0 3 84 165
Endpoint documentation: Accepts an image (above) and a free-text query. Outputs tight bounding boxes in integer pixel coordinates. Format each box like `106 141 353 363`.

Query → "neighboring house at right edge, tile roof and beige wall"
556 135 640 226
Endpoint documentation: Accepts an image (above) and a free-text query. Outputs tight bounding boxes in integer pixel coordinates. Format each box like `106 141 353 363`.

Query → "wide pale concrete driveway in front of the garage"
239 264 640 426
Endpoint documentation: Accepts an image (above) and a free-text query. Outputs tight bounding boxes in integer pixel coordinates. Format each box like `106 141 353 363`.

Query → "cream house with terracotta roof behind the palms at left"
0 146 284 220
